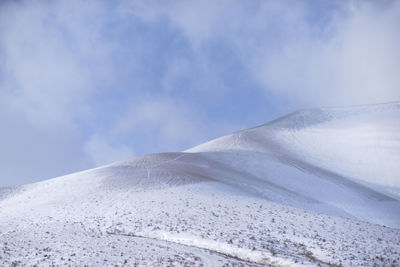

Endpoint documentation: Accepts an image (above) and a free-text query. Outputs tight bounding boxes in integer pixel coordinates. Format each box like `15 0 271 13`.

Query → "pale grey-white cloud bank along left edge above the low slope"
0 1 123 186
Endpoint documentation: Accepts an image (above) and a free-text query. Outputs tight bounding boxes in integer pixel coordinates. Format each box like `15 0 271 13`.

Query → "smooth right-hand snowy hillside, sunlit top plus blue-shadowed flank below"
187 103 400 227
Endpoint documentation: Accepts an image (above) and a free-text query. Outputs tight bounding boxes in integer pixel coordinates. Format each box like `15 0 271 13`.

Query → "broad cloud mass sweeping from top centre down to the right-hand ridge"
144 1 400 107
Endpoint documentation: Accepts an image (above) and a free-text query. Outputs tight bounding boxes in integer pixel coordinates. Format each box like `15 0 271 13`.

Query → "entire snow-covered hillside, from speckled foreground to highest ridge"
0 103 400 266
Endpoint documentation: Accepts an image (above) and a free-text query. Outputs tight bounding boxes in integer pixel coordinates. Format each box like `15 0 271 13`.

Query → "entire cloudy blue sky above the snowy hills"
0 0 400 186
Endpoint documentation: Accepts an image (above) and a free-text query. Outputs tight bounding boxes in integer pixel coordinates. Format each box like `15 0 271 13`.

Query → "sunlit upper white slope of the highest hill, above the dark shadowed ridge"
189 103 400 191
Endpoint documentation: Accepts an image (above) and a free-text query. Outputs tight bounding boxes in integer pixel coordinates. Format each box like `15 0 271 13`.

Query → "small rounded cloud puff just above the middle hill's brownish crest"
110 96 210 152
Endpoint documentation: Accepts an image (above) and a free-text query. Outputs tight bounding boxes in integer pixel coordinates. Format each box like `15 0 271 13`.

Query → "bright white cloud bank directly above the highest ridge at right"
251 2 400 106
